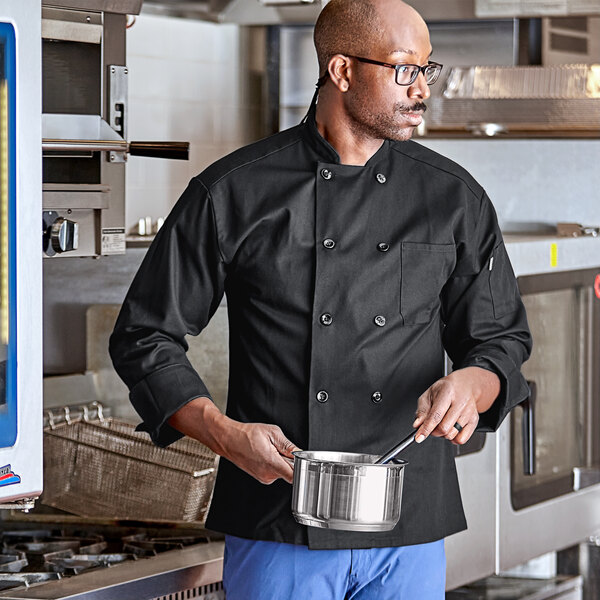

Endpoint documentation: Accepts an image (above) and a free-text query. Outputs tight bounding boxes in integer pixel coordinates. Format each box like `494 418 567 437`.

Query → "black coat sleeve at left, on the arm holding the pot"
109 178 225 446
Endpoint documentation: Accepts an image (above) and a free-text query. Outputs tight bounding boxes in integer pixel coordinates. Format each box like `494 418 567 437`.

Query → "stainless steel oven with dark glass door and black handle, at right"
446 235 600 589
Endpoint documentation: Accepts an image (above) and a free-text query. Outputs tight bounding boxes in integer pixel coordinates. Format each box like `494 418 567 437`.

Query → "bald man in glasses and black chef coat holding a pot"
111 0 530 600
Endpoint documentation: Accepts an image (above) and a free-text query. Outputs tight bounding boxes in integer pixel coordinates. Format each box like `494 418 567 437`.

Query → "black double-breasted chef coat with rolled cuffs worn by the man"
111 106 530 548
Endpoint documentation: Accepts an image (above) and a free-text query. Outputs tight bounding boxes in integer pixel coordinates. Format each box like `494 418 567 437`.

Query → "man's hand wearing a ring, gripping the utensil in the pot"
413 367 500 445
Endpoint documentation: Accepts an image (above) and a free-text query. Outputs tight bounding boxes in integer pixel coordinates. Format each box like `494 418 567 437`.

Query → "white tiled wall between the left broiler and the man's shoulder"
125 14 259 228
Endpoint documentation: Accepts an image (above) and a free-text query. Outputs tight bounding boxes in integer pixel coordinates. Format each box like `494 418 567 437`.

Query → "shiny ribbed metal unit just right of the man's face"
426 64 600 137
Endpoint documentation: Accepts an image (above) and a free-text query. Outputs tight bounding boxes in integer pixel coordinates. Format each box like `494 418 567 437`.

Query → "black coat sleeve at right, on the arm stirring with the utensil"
442 193 532 431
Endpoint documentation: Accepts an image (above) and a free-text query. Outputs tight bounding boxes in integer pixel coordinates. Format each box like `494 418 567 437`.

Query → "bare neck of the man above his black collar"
315 93 383 166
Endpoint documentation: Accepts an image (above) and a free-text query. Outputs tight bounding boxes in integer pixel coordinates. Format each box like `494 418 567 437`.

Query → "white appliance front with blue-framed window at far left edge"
0 0 42 505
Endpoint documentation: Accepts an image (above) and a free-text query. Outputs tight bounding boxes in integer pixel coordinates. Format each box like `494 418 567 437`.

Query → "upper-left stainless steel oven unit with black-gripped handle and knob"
41 0 189 257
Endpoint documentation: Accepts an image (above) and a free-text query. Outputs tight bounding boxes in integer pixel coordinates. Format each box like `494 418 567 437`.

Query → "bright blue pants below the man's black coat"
223 536 446 600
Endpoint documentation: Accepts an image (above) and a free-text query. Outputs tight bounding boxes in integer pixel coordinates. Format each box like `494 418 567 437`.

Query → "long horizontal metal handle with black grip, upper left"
42 139 190 160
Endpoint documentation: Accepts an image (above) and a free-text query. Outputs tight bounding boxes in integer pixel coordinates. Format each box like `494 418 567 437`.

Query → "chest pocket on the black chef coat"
400 242 456 325
